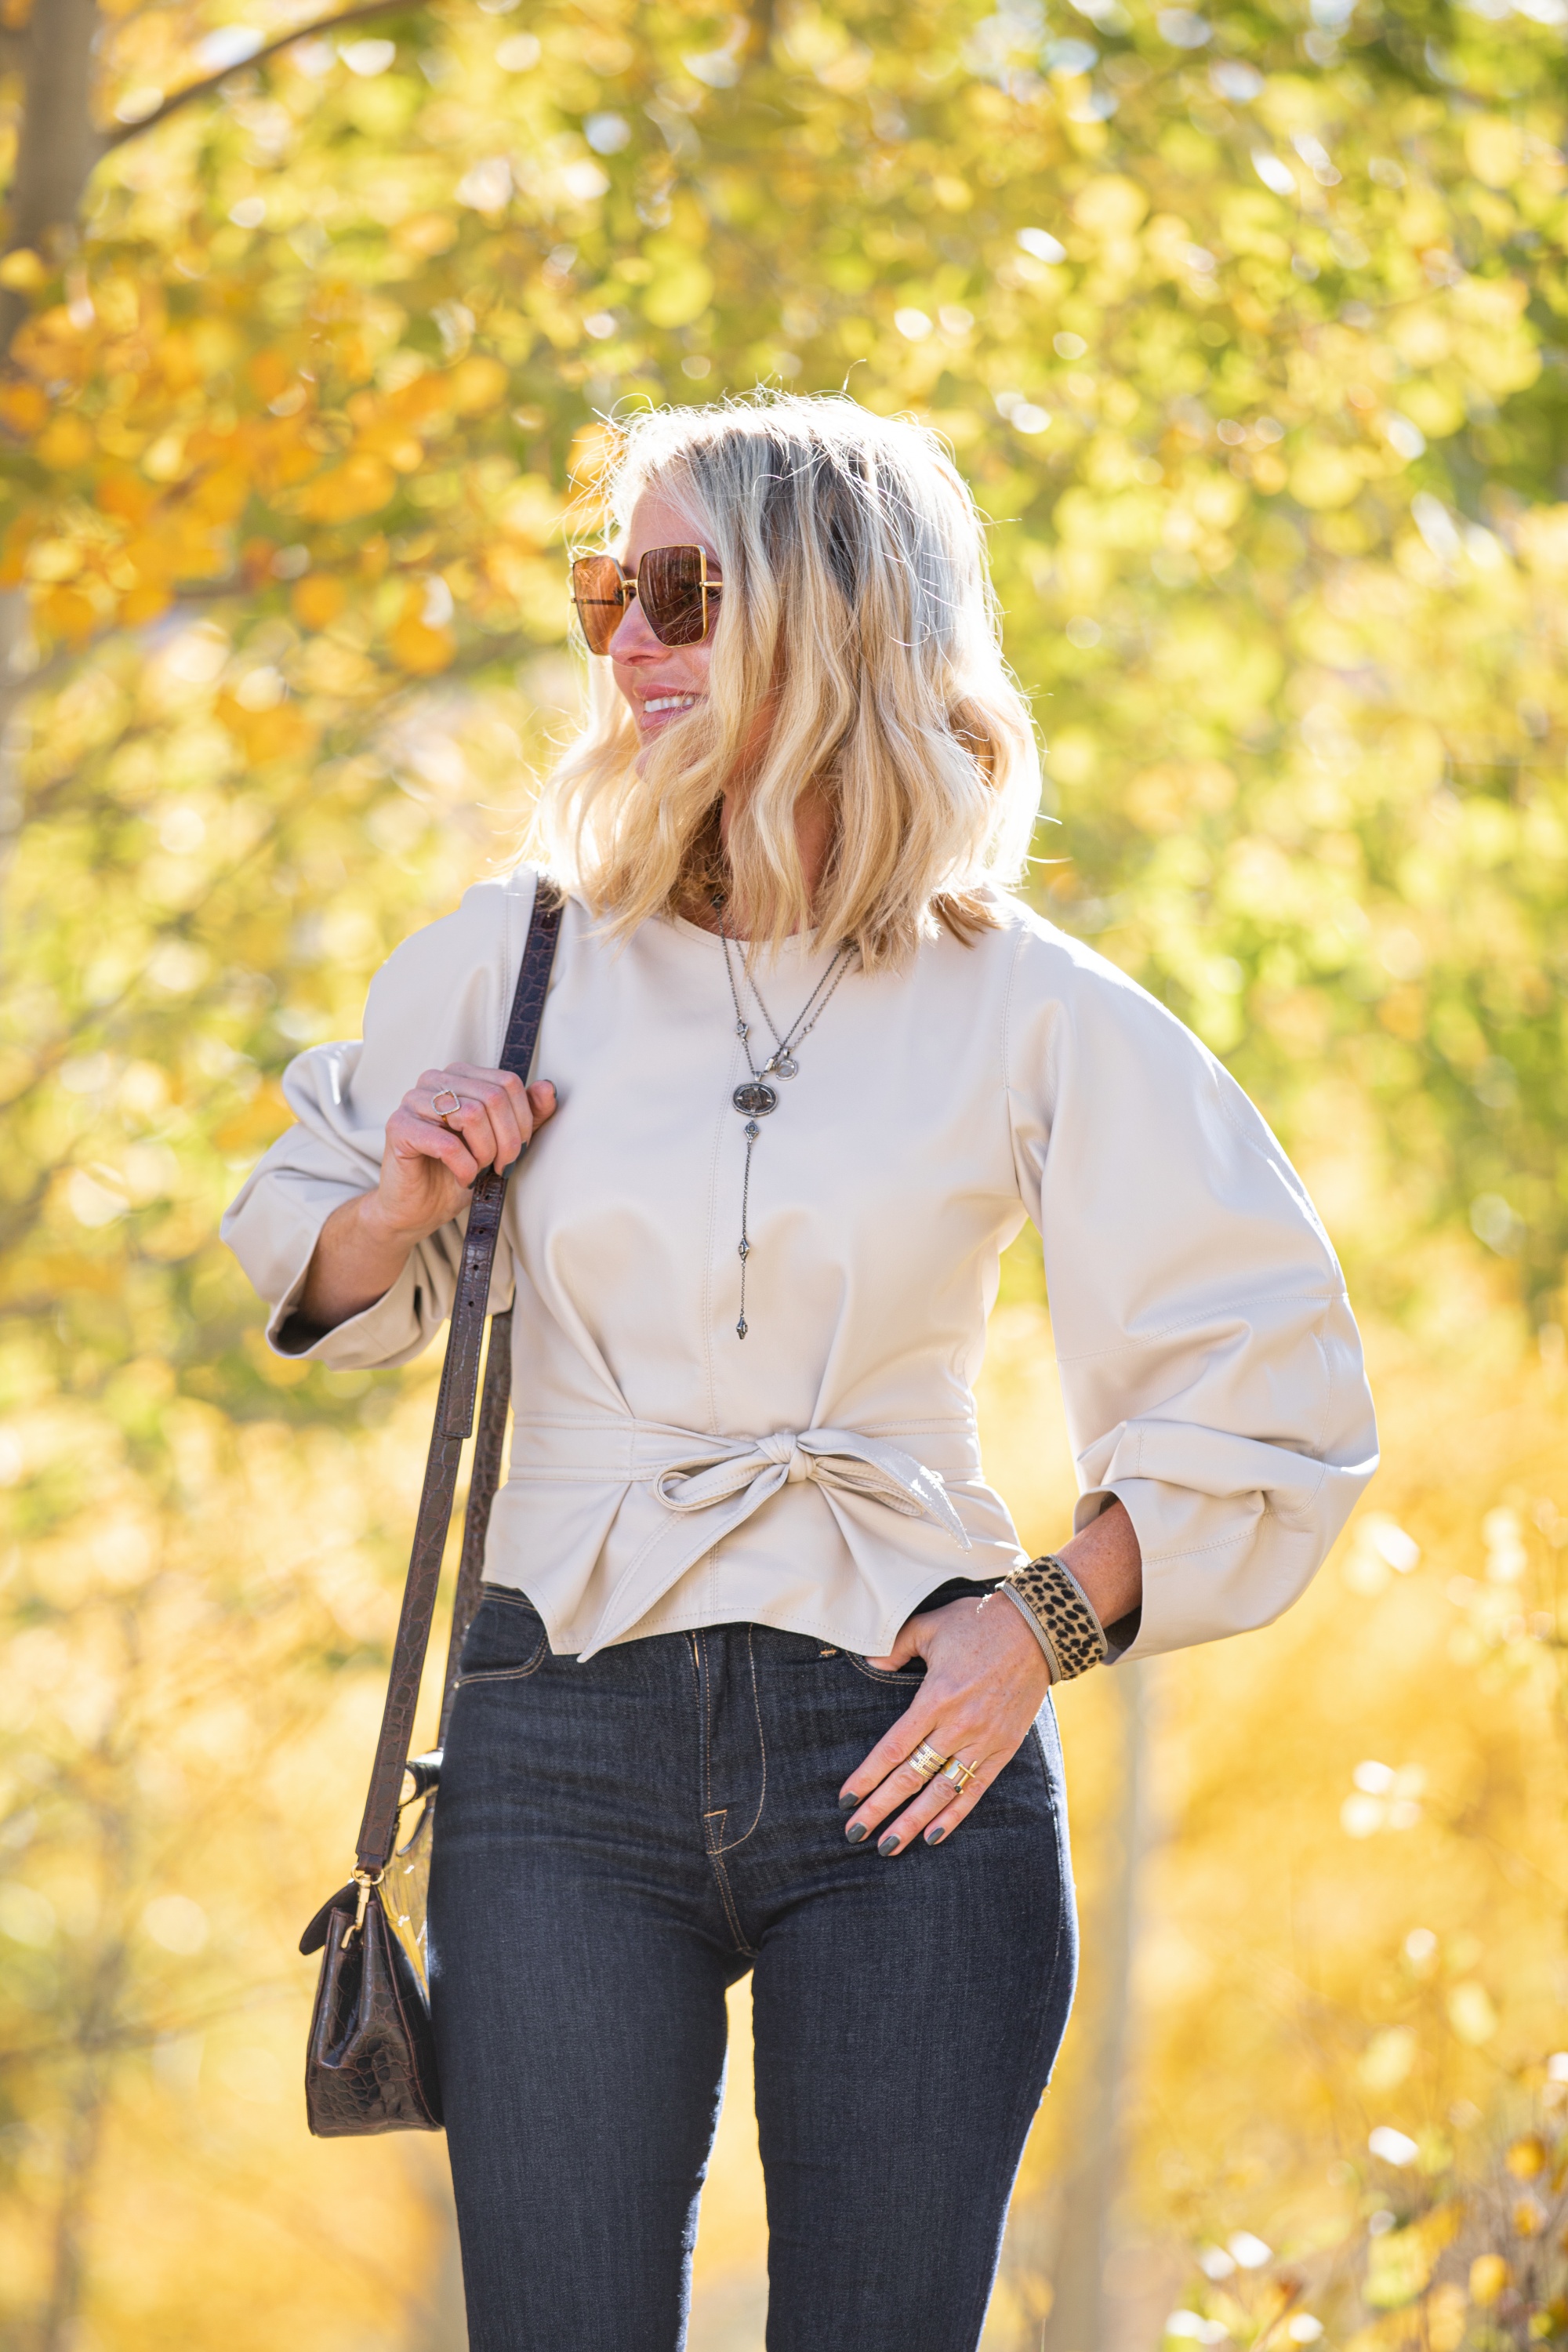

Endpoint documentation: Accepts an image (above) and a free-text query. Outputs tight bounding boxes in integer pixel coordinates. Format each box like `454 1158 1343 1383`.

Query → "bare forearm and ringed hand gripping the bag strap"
296 1061 555 1331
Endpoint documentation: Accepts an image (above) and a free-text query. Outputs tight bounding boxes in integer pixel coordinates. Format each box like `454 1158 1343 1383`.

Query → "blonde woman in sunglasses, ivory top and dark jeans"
228 397 1375 2352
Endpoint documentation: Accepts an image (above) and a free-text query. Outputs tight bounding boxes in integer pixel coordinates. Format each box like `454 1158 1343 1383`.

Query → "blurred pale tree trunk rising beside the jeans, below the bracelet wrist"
1044 1665 1147 2352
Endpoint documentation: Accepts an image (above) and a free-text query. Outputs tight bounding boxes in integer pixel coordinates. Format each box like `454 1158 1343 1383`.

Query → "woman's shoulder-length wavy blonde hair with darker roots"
536 395 1039 969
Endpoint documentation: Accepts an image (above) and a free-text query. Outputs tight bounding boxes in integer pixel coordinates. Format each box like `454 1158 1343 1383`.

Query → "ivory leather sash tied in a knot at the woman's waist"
513 1423 971 1658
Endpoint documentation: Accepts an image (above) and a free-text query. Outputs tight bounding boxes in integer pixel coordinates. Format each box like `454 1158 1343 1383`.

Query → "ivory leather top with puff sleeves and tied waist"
223 868 1377 1656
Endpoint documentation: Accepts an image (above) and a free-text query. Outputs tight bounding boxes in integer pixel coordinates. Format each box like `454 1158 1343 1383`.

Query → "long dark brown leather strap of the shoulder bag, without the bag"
358 880 562 1872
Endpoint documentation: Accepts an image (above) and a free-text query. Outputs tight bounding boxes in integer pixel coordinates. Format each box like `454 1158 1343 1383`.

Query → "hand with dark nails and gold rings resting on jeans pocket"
839 1592 1051 1856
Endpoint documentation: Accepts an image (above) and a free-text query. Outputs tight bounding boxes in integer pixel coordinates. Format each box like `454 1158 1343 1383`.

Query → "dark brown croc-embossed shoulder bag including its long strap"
299 877 562 2138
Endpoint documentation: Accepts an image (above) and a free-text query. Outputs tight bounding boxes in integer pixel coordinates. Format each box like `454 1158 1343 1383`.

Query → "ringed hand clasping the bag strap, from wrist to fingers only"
374 1061 555 1247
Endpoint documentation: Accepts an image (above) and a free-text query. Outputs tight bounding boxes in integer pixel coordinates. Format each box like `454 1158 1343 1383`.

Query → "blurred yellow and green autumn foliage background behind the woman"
0 0 1568 2352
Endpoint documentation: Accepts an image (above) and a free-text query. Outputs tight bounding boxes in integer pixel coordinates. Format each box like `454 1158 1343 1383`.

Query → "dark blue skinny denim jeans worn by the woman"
430 1585 1076 2352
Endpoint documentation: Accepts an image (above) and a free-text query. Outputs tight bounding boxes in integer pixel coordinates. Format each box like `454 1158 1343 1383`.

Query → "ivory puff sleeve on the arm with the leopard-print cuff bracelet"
1006 924 1377 1656
